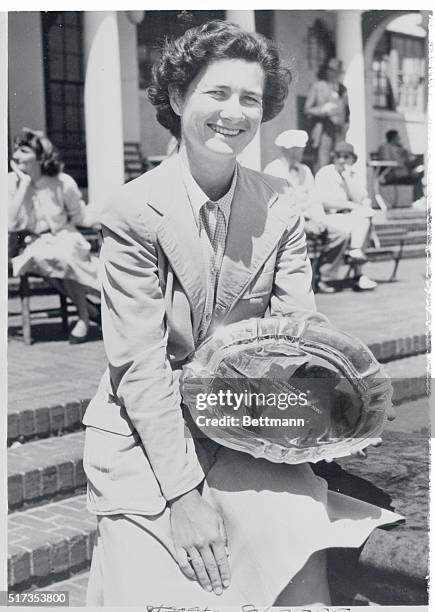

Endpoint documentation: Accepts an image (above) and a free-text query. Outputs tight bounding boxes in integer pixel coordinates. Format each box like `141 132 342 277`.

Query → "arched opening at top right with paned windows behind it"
363 10 428 153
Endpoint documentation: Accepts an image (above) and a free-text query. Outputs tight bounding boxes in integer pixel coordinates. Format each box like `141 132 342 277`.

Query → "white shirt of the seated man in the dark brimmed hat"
314 164 368 207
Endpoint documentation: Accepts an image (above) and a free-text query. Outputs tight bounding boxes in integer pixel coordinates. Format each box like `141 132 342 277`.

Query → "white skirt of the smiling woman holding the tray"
87 449 403 609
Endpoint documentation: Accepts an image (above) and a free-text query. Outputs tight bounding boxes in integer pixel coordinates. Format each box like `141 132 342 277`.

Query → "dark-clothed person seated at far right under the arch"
378 130 424 199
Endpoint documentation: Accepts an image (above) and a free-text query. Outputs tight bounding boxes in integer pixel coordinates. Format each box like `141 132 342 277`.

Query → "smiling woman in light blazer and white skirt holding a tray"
83 22 397 608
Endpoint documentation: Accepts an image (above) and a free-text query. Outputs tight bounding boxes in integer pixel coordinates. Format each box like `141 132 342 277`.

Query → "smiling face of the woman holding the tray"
171 59 265 161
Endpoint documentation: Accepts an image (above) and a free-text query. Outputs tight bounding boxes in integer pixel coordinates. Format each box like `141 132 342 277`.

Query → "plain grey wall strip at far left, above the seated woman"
8 11 46 146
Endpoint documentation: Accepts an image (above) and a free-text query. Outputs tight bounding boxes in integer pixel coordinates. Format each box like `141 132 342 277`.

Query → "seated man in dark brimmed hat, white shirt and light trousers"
314 142 376 291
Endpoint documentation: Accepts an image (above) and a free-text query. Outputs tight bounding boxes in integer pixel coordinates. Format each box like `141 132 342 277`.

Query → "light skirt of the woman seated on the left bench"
12 226 100 294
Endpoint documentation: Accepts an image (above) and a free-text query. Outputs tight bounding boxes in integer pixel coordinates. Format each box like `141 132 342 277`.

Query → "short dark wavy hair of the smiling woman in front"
147 21 291 139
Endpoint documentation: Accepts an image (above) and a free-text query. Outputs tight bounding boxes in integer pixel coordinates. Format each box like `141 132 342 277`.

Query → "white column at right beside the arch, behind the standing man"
336 10 367 176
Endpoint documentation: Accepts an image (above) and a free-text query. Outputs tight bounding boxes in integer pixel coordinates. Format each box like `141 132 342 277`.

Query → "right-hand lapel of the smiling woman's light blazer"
215 166 294 322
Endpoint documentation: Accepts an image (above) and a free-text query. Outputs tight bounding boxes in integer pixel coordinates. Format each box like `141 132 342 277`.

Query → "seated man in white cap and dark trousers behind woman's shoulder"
264 130 349 293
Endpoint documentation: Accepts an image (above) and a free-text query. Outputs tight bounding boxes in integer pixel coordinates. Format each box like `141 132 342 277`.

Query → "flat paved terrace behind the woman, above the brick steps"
8 259 426 412
